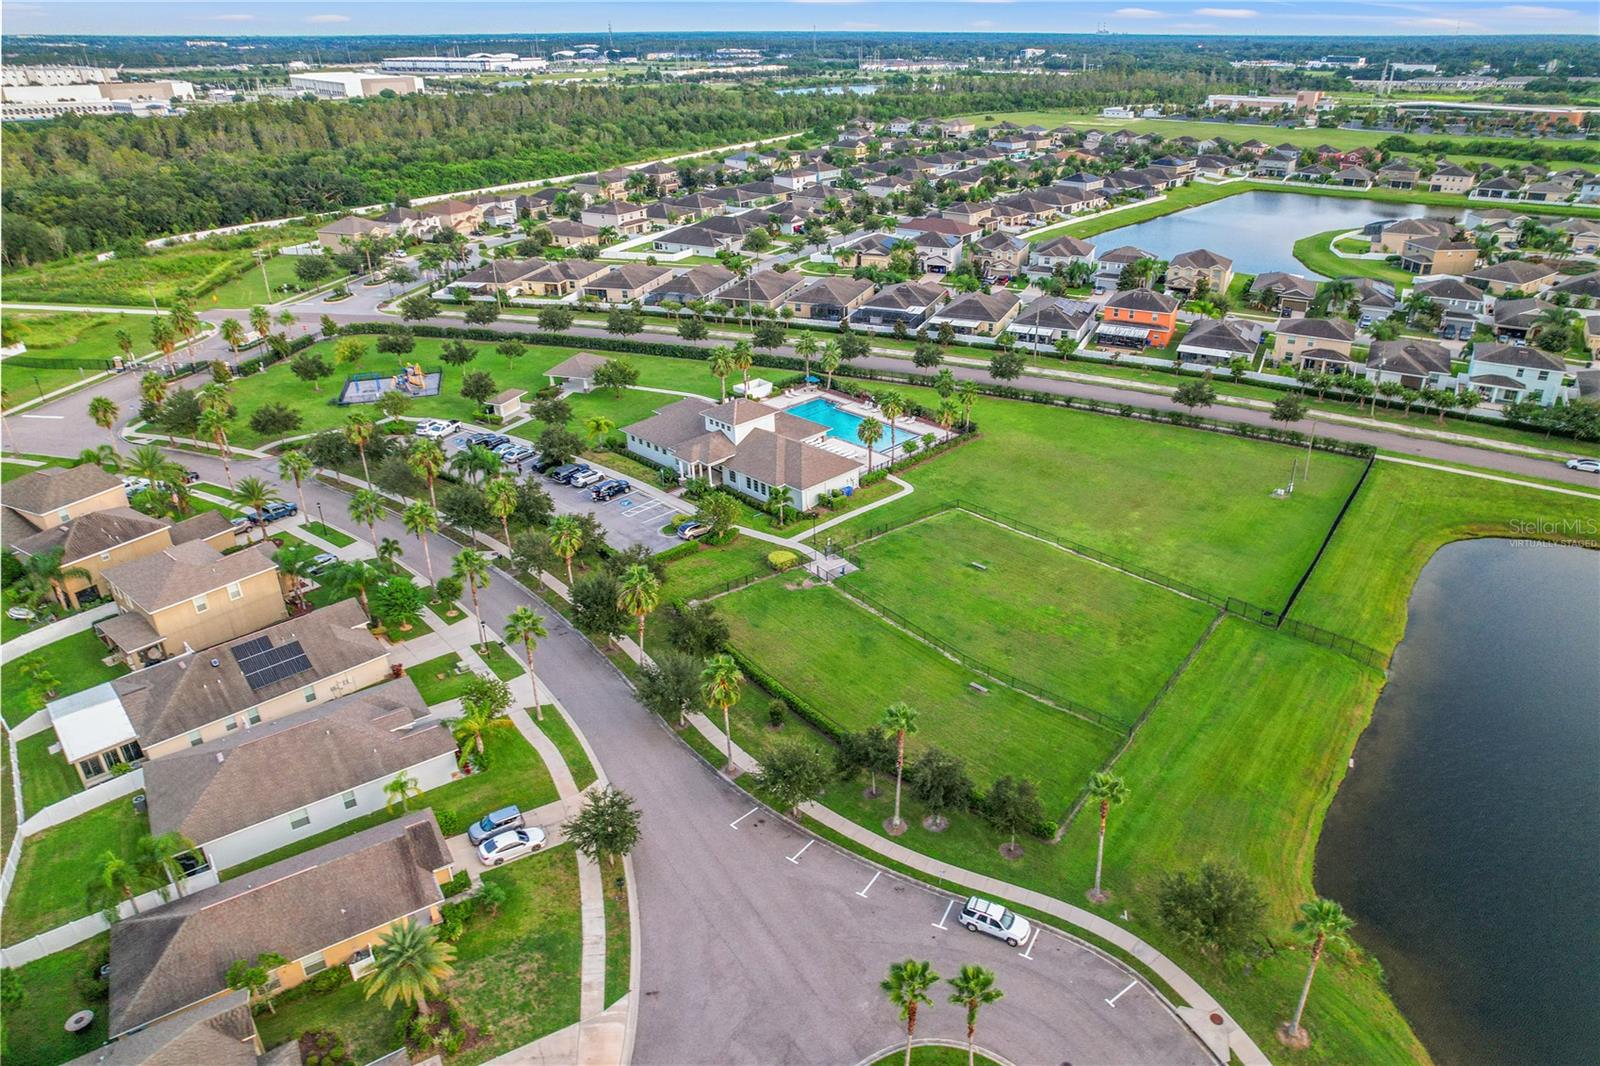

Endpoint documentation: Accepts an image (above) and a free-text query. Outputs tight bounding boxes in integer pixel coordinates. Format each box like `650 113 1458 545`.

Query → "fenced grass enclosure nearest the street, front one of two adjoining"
717 581 1120 818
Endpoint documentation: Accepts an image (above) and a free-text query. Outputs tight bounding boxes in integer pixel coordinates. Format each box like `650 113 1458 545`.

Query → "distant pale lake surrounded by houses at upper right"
1094 192 1461 274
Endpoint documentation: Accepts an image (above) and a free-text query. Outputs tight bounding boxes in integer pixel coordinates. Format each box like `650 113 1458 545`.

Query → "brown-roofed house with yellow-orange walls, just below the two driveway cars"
107 810 453 1039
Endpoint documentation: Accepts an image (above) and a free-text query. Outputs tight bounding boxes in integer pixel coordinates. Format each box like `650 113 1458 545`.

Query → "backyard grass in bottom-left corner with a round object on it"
5 933 110 1064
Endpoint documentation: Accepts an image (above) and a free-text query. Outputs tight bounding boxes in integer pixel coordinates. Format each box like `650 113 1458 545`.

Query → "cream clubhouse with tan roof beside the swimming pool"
622 399 862 511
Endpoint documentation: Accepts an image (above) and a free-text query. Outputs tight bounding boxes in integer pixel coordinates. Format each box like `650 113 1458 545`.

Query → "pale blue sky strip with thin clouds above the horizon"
0 0 1600 37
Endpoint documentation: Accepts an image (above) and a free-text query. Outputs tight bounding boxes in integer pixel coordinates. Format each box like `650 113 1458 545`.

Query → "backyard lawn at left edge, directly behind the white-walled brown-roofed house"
0 795 150 944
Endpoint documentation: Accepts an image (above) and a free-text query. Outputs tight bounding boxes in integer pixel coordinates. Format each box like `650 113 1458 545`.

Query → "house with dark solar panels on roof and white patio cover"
45 600 392 786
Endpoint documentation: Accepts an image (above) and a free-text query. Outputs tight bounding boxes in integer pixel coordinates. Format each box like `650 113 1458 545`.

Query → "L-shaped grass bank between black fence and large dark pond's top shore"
1293 463 1600 650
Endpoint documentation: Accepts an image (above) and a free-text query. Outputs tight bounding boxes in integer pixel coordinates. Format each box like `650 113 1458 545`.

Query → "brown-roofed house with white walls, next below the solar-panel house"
144 677 461 871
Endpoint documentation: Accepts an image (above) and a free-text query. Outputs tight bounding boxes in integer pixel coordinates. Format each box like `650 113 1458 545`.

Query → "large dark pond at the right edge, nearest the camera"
1312 539 1600 1066
